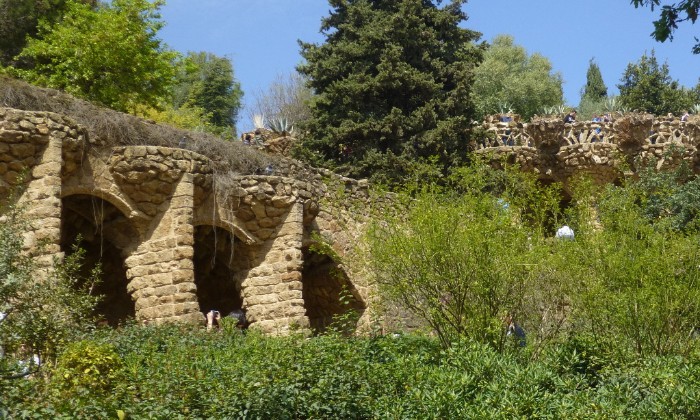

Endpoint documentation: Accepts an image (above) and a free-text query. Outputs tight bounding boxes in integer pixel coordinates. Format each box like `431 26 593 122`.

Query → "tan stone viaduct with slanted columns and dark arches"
0 108 381 334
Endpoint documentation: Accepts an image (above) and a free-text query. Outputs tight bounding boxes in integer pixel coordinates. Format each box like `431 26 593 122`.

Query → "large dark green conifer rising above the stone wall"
299 0 481 182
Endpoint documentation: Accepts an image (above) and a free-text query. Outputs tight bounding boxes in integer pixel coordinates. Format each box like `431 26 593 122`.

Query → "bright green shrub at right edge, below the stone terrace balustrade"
553 178 700 356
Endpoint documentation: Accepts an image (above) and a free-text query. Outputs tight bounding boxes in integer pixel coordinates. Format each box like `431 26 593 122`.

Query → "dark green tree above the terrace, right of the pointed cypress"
617 50 692 115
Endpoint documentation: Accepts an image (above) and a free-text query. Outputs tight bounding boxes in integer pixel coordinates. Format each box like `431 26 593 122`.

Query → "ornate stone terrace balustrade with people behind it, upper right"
476 113 700 187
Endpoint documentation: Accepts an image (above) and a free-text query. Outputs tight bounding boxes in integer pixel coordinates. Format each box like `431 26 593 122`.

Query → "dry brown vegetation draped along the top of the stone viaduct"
0 75 281 175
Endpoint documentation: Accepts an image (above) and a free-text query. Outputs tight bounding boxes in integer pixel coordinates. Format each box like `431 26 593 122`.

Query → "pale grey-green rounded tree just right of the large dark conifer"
473 35 563 118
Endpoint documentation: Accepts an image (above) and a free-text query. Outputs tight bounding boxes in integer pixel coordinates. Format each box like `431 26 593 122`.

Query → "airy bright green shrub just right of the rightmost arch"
368 162 558 350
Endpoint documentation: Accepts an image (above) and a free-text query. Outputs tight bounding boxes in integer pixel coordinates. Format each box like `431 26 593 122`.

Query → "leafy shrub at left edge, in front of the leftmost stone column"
0 200 98 376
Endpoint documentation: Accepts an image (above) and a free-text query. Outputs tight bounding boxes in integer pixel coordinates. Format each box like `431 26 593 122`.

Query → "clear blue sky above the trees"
160 0 700 131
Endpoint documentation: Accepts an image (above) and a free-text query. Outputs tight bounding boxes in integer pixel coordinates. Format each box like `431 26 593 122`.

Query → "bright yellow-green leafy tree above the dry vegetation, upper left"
15 0 175 111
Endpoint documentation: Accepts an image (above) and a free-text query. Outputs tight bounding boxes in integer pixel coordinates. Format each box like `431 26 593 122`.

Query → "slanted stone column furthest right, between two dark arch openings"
242 202 309 335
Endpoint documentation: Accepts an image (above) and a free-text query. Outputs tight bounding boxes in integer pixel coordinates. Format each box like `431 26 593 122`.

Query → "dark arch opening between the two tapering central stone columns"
193 224 248 315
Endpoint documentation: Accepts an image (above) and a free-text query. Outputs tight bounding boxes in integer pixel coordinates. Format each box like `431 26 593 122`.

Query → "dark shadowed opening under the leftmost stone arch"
61 194 138 326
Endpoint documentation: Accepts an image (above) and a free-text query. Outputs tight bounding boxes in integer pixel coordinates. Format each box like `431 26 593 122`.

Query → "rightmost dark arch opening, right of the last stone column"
302 242 367 333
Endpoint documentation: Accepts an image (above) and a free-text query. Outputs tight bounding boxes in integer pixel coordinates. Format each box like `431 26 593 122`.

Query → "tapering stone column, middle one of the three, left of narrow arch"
126 173 204 322
